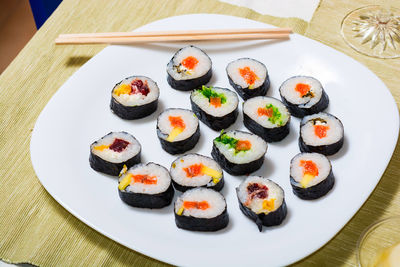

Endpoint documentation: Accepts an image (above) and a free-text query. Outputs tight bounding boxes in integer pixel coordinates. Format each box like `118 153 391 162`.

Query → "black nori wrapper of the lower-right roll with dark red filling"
236 188 287 232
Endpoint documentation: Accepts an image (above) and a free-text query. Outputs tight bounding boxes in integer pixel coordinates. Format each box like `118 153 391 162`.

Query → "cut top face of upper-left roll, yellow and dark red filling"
112 76 159 107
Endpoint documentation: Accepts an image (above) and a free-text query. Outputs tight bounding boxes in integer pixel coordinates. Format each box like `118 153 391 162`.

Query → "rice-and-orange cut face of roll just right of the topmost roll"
227 58 268 89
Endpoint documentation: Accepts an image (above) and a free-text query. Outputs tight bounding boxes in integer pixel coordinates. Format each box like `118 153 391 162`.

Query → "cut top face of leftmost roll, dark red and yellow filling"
91 132 141 163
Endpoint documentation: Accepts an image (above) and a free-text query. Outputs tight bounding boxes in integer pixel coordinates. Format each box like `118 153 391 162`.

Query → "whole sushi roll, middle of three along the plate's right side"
299 112 344 156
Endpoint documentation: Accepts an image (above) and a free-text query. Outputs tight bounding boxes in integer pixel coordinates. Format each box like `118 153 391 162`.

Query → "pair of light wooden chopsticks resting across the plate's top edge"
55 28 292 45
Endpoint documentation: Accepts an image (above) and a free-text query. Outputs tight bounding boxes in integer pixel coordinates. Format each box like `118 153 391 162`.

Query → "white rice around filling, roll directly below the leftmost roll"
119 162 171 195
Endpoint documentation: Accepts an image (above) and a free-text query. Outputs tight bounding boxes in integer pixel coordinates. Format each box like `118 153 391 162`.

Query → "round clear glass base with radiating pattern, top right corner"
341 5 400 58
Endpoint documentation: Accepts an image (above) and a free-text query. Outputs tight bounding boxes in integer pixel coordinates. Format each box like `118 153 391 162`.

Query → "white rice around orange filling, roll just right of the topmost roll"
226 58 268 88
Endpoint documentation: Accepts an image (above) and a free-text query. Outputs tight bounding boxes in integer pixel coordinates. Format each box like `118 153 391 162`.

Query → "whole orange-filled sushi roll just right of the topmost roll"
226 58 270 100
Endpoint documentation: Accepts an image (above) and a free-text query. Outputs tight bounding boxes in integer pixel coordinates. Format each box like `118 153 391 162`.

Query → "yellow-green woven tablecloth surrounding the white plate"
0 0 400 266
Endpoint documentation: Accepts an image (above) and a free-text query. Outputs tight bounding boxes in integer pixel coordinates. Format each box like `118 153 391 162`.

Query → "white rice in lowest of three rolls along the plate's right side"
290 153 331 187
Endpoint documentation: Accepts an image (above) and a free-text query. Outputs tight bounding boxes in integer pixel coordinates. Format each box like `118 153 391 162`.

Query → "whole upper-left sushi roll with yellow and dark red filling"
110 76 160 120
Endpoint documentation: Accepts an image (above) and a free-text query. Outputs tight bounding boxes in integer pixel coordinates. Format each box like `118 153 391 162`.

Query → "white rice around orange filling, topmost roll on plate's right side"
279 76 323 108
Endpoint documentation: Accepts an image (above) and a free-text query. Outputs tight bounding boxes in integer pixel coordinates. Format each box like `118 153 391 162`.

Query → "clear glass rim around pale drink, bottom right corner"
357 216 400 267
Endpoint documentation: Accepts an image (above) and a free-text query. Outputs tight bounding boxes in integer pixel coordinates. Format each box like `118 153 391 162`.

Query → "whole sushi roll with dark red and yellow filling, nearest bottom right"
236 176 287 232
